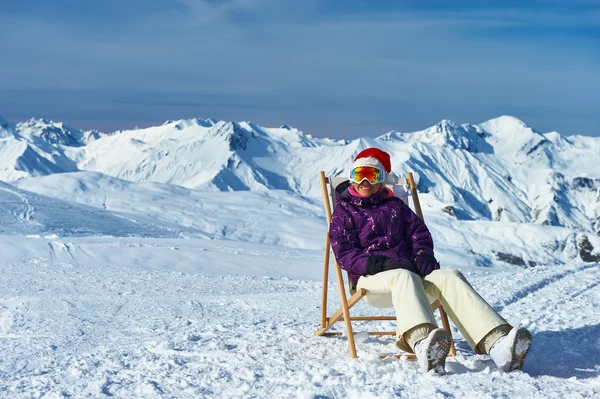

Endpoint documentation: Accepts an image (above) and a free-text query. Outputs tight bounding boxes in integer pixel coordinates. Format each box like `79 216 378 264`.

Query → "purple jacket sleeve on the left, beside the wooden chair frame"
329 206 369 276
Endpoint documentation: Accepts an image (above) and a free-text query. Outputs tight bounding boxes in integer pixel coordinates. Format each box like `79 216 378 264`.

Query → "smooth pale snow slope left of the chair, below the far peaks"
14 172 325 248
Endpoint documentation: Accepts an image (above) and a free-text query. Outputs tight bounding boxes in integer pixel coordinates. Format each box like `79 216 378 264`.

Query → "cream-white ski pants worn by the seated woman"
356 269 508 353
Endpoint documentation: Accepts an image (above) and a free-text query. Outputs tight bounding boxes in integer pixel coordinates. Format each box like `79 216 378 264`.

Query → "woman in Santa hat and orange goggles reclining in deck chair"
329 148 532 372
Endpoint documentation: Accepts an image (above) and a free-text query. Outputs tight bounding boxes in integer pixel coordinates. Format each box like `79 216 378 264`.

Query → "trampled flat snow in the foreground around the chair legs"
0 247 600 399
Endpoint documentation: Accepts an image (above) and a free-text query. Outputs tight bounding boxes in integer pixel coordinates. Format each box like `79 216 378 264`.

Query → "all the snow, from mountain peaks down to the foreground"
0 117 600 399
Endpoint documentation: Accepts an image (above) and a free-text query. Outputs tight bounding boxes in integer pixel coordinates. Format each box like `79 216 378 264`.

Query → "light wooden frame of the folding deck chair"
315 172 456 359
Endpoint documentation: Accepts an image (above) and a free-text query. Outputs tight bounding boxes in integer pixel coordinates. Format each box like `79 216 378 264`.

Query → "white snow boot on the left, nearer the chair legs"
414 328 452 374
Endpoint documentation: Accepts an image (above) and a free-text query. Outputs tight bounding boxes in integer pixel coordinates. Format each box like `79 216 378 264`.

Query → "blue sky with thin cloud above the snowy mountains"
0 0 600 138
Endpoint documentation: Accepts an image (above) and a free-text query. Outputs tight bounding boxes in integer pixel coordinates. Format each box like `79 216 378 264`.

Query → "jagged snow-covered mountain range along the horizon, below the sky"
0 116 600 234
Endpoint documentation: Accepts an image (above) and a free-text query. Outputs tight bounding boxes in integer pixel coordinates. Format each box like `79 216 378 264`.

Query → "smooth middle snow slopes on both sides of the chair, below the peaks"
8 172 600 267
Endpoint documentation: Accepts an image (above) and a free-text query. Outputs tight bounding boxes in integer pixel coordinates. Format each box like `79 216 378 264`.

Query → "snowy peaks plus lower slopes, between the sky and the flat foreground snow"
0 116 600 265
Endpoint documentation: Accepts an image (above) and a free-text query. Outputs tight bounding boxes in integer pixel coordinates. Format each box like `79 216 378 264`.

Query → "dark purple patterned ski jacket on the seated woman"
329 181 433 283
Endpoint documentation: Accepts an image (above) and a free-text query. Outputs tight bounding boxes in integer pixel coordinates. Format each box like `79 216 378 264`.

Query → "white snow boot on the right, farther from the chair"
490 327 531 372
